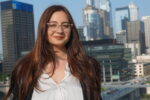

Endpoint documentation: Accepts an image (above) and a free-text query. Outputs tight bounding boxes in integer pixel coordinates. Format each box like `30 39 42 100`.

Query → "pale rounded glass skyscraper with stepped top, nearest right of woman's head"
83 0 102 40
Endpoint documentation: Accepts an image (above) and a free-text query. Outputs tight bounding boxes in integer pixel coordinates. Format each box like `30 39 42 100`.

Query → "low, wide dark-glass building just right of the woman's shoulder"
82 39 133 82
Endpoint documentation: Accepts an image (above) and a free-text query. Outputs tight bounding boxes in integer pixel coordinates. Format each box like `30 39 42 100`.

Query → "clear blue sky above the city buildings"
0 0 150 53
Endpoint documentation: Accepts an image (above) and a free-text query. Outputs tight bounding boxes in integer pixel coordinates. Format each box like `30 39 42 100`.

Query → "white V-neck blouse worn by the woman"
32 64 83 100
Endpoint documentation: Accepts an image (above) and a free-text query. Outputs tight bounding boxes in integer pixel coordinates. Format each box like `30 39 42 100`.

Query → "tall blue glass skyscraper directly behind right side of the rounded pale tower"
95 0 114 39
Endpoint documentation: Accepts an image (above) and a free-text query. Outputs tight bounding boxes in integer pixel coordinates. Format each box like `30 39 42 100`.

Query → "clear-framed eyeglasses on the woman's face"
47 22 73 31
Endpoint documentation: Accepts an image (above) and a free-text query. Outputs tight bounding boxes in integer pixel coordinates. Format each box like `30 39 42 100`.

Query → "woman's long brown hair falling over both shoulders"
2 5 100 100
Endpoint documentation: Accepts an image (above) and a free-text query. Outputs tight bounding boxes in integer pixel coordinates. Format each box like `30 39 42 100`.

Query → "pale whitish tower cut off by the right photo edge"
142 16 150 54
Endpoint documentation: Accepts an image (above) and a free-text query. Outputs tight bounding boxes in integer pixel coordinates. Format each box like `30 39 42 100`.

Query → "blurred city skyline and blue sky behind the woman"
0 0 150 100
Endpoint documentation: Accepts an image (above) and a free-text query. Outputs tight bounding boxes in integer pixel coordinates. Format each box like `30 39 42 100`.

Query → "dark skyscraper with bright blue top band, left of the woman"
0 1 34 74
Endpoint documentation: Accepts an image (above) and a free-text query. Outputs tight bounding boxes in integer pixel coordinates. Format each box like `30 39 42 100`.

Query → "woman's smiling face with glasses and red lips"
47 11 72 47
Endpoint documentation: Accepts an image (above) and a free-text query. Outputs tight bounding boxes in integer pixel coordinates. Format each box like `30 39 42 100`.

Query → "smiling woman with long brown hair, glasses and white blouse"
4 5 101 100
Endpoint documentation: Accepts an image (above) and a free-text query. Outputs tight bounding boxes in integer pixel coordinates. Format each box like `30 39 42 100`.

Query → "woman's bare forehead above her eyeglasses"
49 11 69 22
